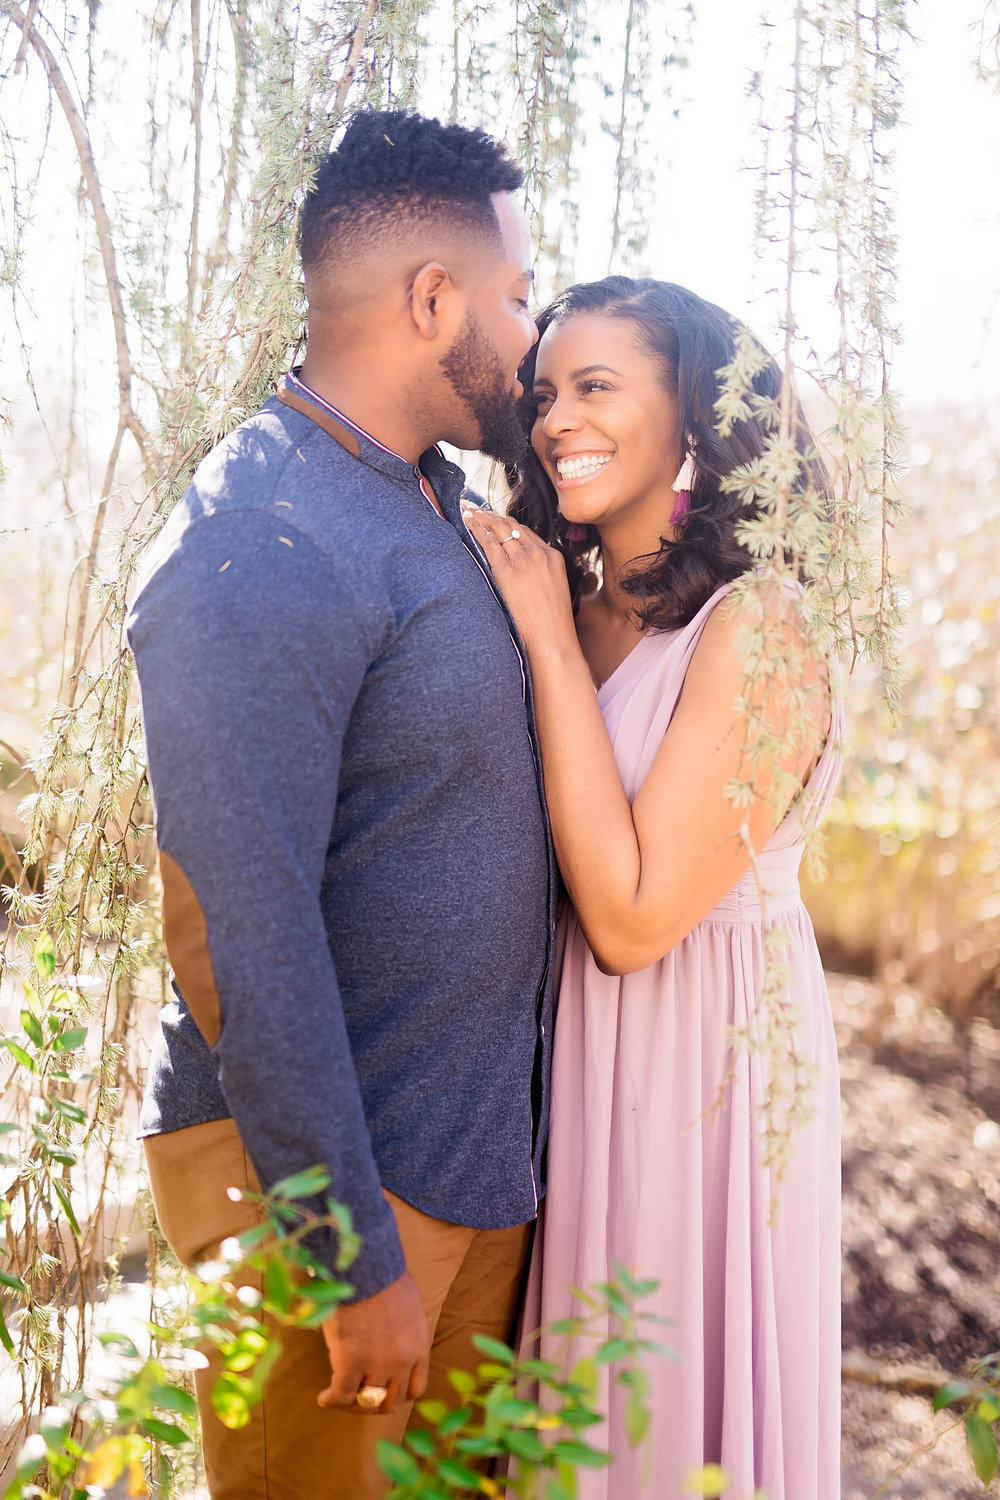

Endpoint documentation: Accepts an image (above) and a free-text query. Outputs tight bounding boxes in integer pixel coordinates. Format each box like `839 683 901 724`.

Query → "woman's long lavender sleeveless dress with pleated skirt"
526 590 841 1500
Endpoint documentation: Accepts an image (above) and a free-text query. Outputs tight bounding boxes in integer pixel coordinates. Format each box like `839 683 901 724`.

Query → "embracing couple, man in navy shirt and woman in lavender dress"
129 111 840 1500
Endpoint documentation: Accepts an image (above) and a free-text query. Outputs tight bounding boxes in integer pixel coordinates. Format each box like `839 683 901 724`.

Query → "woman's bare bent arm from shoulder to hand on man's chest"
467 504 829 974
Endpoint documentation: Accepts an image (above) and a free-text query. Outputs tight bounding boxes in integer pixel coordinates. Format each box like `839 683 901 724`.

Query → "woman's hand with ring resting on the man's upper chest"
462 501 579 656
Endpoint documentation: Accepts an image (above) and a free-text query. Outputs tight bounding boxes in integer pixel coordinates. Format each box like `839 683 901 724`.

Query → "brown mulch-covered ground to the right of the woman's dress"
833 975 1000 1500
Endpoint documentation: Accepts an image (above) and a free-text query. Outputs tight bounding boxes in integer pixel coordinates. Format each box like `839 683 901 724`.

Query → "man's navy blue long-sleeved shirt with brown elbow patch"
129 378 556 1296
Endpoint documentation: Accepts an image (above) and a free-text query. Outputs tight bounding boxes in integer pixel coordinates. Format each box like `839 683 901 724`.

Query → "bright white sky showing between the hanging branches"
0 0 1000 453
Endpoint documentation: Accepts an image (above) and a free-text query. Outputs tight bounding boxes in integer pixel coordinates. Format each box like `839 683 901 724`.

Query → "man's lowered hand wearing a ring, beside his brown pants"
316 1272 430 1412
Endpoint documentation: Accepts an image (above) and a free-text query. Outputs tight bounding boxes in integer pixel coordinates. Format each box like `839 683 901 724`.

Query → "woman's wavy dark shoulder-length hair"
508 276 829 630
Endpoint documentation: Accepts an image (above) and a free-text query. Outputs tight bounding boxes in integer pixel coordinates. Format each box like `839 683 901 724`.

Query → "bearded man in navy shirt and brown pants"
129 111 555 1500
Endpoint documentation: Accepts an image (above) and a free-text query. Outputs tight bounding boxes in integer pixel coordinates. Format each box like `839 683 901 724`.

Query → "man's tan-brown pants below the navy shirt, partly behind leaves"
144 1119 531 1500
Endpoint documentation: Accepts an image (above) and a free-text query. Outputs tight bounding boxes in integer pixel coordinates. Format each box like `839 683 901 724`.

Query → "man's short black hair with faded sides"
298 110 525 270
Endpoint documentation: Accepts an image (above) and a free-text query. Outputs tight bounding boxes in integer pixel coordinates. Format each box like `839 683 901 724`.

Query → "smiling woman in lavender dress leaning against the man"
466 278 840 1500
